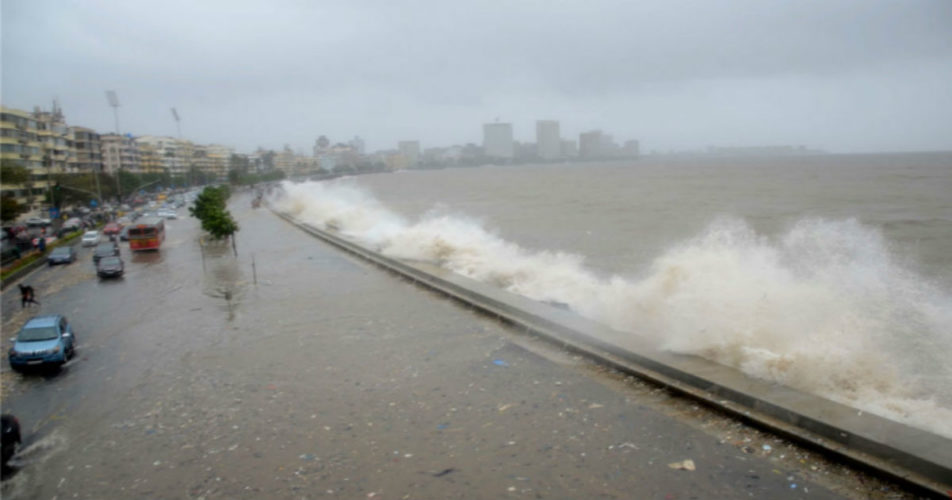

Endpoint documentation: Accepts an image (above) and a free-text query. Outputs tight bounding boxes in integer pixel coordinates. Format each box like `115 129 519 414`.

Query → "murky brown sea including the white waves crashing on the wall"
271 152 952 438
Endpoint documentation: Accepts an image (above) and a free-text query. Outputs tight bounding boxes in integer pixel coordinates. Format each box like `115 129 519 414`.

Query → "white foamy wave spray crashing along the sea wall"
271 165 952 437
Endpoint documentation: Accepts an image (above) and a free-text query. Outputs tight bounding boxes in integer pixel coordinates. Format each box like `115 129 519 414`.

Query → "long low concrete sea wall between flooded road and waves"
278 213 952 498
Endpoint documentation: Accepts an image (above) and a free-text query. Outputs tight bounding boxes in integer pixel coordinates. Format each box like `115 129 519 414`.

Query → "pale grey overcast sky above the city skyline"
2 0 952 153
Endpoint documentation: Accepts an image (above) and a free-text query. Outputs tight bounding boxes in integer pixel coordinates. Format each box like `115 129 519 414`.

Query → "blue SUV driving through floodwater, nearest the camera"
10 314 76 371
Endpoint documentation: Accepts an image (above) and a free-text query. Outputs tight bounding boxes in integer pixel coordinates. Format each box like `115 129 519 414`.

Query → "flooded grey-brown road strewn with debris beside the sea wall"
2 195 924 499
